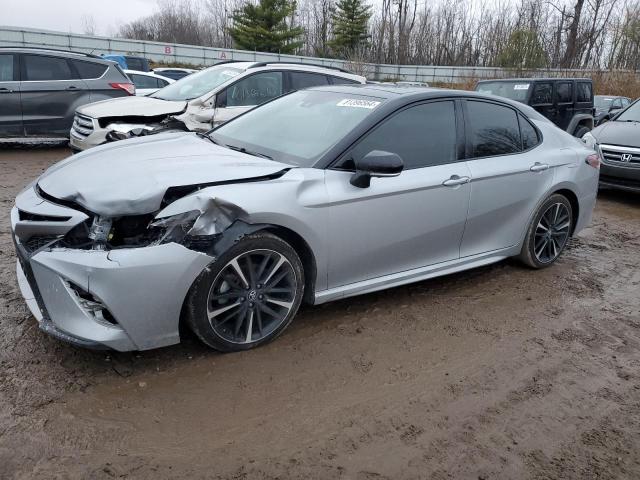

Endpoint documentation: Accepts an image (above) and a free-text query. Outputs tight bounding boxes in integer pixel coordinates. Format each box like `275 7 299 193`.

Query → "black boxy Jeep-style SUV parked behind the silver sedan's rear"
476 78 594 138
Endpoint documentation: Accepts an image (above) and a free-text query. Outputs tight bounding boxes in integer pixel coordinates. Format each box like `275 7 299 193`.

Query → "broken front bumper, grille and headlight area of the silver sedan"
11 182 262 351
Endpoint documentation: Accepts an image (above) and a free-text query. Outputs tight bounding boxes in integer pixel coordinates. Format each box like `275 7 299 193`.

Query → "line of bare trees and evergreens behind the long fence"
118 0 640 70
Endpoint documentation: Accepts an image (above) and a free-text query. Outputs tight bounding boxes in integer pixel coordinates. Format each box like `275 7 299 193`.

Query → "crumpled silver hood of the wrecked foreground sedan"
38 133 290 217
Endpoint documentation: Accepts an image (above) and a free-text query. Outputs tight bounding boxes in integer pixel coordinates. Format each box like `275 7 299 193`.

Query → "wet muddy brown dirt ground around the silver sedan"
0 149 640 480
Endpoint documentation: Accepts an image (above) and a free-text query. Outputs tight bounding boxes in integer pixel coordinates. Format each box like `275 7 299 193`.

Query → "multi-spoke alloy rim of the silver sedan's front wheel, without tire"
207 250 297 343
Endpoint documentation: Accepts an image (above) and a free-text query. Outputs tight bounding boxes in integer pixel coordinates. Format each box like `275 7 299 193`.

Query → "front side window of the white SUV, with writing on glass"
217 72 282 108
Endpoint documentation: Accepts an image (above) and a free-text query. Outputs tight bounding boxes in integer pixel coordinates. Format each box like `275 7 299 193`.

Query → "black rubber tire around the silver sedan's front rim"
185 231 305 352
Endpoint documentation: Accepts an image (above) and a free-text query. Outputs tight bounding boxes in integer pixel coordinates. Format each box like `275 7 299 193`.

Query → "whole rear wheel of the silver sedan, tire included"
519 194 573 269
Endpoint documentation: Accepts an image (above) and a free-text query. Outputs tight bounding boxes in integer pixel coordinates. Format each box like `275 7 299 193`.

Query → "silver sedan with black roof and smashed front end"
11 86 600 351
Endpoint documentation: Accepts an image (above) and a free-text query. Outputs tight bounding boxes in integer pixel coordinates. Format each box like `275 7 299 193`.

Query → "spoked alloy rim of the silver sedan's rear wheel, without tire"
533 203 571 263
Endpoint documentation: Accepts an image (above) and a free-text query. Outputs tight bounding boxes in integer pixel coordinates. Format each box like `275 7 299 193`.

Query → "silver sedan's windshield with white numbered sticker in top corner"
210 90 382 167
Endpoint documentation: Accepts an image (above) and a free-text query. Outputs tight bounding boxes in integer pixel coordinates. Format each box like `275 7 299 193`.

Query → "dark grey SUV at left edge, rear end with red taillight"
0 47 135 139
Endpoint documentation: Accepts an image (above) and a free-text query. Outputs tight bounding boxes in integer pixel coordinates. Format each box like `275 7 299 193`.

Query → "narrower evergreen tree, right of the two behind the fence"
331 0 371 55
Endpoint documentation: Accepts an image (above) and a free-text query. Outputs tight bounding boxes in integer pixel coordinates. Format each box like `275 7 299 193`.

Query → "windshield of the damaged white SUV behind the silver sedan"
151 65 242 101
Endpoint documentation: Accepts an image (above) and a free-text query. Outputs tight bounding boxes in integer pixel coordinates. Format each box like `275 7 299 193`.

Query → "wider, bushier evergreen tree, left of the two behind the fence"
229 0 304 53
